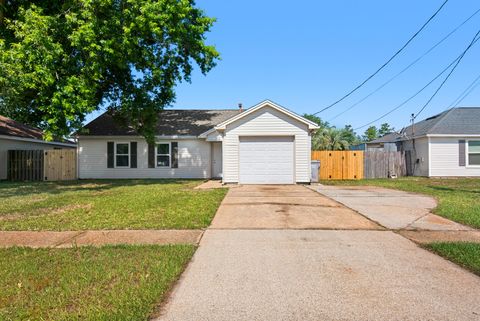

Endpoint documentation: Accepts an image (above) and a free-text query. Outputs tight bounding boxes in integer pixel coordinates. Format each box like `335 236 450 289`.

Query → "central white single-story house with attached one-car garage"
78 100 318 184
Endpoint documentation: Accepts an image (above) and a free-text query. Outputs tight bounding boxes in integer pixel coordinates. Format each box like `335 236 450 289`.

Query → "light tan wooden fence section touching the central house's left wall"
43 149 77 181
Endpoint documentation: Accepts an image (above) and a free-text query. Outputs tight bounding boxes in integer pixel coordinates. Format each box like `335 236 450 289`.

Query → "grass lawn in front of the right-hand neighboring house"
322 177 480 228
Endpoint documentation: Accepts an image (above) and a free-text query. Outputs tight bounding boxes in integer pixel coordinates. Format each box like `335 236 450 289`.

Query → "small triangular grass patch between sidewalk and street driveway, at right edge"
424 242 480 276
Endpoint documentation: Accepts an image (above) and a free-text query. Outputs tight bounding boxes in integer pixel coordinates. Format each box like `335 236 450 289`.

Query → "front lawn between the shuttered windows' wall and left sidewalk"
0 180 226 231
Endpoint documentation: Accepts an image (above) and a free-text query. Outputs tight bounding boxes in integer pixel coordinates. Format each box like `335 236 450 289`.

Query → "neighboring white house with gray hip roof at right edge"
367 107 480 177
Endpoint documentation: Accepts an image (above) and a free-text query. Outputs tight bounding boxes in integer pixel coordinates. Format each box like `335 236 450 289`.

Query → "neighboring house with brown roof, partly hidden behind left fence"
0 116 76 179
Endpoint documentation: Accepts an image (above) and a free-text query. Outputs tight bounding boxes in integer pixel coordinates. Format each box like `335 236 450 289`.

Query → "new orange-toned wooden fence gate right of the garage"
312 150 363 179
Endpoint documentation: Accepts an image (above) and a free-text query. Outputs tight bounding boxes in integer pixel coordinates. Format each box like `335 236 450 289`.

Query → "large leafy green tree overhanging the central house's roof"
0 0 219 141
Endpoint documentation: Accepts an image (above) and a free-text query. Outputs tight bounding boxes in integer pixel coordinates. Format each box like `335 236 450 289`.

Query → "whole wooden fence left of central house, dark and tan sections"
7 149 77 181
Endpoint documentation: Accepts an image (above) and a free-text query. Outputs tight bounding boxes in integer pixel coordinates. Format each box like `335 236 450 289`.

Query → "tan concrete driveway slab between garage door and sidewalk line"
210 185 381 229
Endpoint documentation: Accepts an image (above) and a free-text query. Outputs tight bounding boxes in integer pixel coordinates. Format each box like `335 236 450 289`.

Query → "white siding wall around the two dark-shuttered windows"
78 137 211 178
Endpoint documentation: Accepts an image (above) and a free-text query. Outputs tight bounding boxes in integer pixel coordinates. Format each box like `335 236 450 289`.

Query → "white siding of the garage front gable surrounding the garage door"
223 107 311 183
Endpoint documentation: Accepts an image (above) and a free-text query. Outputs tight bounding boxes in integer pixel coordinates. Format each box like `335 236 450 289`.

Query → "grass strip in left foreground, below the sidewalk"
0 245 195 320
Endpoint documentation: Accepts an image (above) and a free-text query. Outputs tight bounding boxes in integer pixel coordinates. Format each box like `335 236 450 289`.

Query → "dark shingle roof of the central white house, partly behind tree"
79 109 244 136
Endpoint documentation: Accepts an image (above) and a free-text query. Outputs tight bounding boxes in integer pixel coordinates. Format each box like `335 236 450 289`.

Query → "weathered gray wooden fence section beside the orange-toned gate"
364 151 407 178
